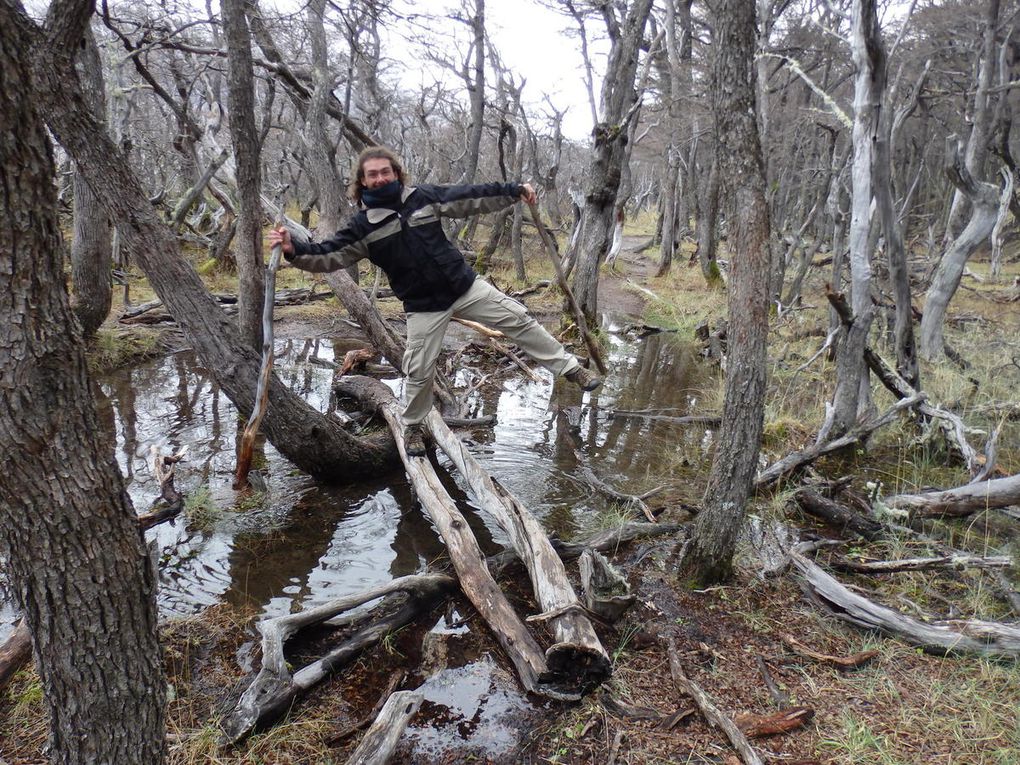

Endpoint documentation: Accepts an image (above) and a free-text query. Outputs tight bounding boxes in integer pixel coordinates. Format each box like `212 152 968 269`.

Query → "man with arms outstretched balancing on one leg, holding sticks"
269 146 602 457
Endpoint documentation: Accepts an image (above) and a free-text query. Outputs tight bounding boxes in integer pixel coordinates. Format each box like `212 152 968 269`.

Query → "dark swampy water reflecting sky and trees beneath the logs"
0 325 712 757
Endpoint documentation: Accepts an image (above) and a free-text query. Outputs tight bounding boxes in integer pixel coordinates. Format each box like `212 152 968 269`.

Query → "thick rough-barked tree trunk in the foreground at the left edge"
0 3 165 765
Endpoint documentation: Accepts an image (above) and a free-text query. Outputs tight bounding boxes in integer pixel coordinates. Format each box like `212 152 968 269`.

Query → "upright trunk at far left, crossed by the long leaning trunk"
70 30 113 338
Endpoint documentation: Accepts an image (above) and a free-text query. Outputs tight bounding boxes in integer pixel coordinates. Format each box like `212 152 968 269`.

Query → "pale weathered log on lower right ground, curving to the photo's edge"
789 549 1020 659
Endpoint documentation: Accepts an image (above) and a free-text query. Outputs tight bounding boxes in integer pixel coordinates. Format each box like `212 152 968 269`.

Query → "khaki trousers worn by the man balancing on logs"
402 278 580 425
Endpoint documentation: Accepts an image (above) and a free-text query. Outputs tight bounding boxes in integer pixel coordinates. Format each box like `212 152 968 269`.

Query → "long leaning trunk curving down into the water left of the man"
17 0 396 480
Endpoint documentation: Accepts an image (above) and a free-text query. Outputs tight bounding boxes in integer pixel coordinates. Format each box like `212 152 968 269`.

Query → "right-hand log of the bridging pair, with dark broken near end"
420 410 611 687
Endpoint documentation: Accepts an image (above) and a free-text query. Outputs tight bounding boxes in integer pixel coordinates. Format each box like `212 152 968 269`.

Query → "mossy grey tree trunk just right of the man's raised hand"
573 0 652 326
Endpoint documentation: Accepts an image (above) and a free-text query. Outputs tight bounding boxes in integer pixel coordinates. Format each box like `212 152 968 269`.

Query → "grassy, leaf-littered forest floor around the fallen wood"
0 230 1020 765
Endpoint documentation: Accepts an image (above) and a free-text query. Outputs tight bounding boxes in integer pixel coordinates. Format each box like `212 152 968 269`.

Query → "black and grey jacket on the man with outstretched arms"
288 184 522 311
